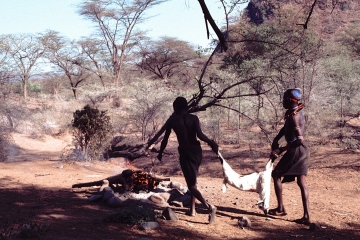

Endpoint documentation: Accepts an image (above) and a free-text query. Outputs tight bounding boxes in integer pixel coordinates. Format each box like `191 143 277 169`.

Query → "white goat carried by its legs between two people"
218 152 273 215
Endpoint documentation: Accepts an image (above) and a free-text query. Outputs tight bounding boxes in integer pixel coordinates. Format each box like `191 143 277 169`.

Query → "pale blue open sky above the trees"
0 0 245 47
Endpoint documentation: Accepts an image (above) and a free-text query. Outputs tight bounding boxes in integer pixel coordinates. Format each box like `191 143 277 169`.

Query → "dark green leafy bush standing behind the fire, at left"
72 105 112 158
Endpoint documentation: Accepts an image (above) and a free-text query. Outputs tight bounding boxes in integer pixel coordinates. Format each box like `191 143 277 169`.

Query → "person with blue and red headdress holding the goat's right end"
269 88 311 225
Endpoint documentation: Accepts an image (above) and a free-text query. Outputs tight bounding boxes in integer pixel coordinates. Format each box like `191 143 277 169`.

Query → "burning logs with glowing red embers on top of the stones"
72 169 170 192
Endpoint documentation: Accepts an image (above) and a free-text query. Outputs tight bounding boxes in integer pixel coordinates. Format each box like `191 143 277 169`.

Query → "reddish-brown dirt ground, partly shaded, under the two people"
0 134 360 240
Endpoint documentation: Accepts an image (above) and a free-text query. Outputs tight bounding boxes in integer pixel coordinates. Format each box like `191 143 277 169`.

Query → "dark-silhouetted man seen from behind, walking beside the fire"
157 97 218 224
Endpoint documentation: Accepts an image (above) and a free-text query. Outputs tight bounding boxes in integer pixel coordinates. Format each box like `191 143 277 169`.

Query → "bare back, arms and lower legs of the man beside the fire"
157 110 218 219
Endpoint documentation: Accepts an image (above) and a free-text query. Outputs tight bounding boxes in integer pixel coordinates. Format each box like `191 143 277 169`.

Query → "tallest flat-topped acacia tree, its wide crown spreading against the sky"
79 0 166 86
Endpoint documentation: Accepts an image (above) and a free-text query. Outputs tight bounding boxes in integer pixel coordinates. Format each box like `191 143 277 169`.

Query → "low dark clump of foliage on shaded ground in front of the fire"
104 205 161 225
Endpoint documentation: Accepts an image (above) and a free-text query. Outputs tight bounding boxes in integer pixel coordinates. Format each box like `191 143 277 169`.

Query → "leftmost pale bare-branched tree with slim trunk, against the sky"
5 34 45 99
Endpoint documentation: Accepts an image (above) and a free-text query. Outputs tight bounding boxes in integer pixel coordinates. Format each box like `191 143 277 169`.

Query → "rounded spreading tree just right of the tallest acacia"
137 37 198 79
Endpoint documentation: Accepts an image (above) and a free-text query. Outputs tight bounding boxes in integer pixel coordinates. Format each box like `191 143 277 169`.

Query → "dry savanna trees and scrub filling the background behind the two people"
0 0 360 160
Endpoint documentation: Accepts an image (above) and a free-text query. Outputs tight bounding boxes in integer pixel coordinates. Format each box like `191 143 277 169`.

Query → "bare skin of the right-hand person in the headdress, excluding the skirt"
270 94 310 223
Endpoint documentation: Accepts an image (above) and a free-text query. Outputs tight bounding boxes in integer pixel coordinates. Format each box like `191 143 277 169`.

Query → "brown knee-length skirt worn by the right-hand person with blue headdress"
272 144 310 182
